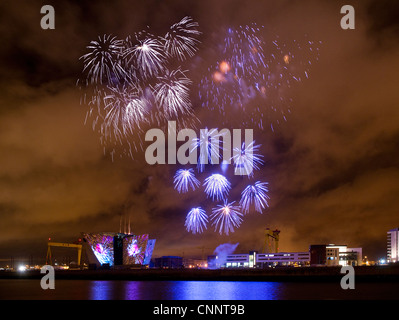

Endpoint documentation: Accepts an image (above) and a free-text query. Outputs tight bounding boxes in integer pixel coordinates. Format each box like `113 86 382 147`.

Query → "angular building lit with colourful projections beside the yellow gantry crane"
83 232 155 266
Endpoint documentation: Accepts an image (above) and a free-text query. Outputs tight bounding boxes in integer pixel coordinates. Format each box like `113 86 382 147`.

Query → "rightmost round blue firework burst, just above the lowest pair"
240 181 269 214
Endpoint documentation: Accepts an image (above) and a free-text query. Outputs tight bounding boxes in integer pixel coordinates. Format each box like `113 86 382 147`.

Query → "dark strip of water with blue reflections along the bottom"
0 279 399 300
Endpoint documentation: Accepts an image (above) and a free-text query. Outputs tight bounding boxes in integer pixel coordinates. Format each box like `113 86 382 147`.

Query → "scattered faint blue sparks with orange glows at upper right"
199 23 319 130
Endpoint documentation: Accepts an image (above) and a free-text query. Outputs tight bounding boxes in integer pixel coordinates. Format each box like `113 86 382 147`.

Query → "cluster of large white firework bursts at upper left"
78 17 200 157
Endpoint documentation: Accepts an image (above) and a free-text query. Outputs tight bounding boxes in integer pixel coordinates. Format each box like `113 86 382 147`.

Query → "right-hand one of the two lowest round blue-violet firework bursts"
211 201 243 235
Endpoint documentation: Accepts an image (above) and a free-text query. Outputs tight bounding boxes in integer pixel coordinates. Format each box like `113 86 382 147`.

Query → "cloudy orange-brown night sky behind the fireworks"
0 0 399 263
